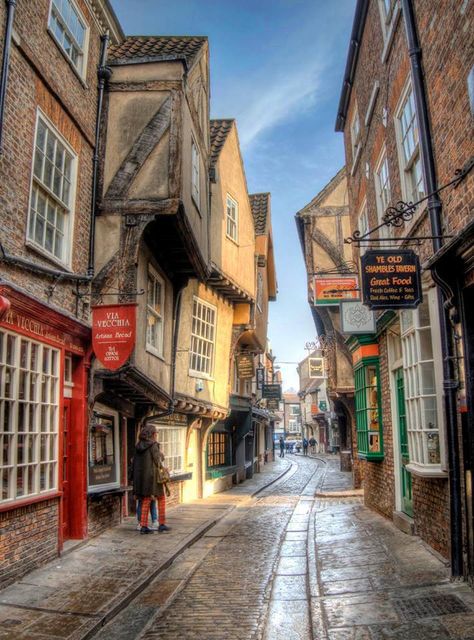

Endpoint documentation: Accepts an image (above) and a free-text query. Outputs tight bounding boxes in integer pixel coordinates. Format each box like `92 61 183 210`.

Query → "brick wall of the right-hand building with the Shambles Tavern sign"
338 0 462 556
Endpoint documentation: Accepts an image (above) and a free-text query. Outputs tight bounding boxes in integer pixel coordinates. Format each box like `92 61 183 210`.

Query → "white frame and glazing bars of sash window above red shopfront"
25 109 78 268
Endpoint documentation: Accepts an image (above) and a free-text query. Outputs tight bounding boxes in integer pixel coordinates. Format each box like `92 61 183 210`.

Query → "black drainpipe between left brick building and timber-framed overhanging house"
87 33 112 277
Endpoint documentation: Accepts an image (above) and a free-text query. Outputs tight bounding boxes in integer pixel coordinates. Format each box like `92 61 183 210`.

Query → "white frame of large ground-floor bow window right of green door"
400 288 446 477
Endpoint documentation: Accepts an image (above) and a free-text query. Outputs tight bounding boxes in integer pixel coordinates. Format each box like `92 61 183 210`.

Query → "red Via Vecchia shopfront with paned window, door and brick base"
0 285 90 585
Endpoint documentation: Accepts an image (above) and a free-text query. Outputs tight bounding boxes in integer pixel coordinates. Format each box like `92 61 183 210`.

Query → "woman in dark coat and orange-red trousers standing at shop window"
133 424 170 534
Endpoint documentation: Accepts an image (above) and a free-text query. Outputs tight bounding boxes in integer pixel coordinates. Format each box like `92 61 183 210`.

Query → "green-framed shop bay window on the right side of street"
354 357 383 460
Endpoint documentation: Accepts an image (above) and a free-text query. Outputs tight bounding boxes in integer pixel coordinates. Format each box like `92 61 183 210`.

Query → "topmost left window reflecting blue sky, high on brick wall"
48 0 87 77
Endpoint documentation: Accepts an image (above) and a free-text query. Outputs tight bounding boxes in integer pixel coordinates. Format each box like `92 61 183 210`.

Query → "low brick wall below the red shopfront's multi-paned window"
0 499 59 589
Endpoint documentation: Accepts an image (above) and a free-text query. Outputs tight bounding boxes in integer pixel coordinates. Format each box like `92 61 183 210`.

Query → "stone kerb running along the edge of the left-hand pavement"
68 464 293 640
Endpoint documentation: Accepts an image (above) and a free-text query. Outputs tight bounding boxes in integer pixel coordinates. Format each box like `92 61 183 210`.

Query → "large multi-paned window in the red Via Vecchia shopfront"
0 331 59 503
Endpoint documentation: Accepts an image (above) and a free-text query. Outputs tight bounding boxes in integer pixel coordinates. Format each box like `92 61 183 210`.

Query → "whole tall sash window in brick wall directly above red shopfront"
27 116 76 264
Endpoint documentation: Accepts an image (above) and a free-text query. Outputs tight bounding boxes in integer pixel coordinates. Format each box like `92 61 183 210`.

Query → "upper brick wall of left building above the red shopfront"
0 0 100 320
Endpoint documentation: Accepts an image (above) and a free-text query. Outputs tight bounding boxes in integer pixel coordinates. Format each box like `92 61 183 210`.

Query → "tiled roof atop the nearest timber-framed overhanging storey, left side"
108 36 207 68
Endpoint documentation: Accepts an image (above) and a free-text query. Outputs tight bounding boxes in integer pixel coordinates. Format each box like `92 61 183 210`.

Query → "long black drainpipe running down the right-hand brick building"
402 0 463 578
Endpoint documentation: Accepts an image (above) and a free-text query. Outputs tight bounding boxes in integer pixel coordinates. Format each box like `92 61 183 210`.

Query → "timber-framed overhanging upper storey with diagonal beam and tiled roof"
96 36 209 279
